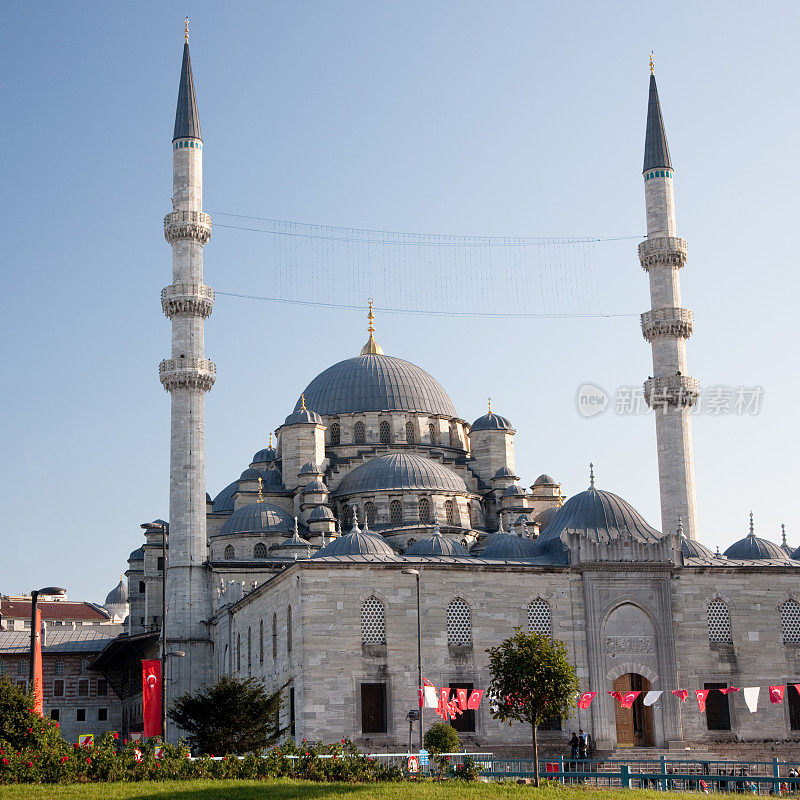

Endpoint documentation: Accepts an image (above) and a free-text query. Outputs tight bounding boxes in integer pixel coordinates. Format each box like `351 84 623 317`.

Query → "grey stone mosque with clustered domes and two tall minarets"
99 35 800 753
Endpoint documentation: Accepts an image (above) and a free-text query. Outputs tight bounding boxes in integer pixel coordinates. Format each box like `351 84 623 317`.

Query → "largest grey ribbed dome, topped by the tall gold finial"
295 354 456 417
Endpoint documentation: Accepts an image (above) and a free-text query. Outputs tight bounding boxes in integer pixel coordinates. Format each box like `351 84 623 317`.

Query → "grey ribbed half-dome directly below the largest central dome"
334 453 468 496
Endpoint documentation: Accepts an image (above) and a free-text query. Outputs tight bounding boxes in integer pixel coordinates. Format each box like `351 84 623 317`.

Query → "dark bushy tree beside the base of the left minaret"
169 675 285 755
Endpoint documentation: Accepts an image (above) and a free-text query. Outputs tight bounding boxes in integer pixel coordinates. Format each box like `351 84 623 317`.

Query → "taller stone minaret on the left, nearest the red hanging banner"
158 19 216 732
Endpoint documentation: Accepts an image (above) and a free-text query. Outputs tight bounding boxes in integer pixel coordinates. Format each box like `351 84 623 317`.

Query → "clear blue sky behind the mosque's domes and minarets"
0 2 800 601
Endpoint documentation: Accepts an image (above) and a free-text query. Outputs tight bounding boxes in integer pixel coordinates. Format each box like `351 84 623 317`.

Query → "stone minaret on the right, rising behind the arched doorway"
639 53 699 539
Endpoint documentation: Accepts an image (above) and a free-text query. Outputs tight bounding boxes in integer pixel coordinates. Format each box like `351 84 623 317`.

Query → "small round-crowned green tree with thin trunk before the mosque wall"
486 628 578 786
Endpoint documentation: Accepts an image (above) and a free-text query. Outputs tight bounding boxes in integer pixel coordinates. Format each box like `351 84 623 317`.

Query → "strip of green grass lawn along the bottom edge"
0 780 697 800
